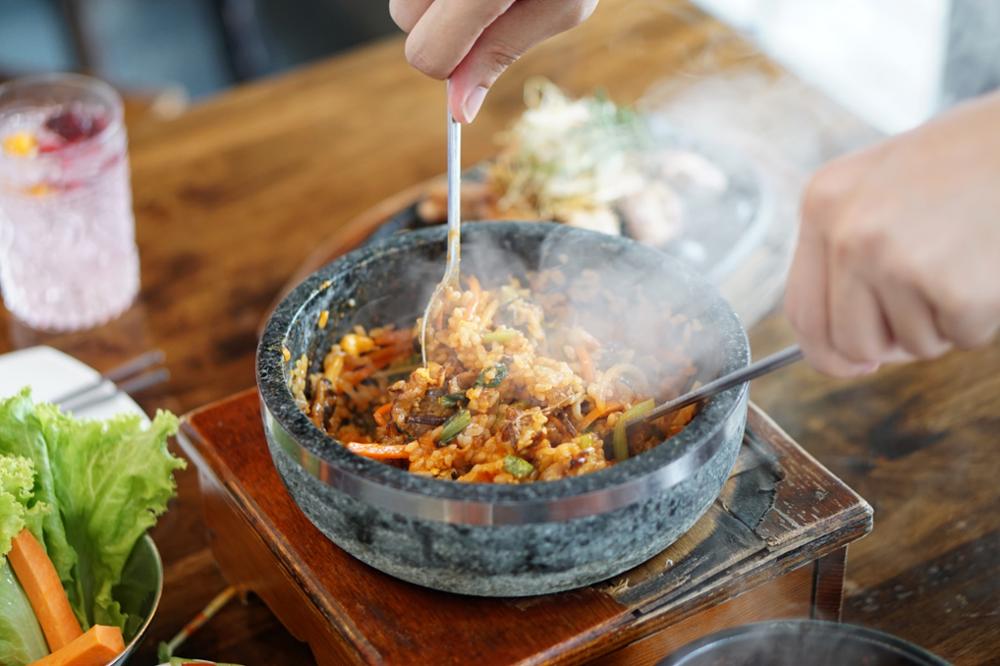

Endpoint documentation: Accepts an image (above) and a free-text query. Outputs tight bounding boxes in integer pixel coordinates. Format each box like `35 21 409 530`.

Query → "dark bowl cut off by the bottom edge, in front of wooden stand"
659 620 948 666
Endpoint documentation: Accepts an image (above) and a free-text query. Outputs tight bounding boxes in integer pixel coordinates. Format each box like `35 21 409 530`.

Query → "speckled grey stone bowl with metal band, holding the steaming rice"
257 222 749 596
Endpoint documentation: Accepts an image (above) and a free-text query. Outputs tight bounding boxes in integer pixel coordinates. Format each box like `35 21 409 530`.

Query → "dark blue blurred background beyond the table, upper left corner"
0 0 396 105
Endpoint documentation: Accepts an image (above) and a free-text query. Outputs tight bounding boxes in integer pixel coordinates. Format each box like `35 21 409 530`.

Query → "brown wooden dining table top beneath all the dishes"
0 0 1000 664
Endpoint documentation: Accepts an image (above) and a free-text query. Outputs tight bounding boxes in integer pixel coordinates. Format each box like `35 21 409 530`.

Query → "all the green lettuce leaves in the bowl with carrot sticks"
0 390 184 666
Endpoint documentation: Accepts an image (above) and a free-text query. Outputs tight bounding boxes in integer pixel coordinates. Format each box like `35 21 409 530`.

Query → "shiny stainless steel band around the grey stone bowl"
261 385 748 525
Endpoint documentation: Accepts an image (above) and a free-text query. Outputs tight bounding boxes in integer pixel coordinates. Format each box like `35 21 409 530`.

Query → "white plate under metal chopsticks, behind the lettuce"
0 347 146 419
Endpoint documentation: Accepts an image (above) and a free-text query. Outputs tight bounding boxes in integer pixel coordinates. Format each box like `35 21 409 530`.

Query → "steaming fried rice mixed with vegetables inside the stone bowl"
290 272 695 483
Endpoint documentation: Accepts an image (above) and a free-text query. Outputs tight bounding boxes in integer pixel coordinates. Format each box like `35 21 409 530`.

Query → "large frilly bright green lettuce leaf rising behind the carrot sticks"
0 391 184 636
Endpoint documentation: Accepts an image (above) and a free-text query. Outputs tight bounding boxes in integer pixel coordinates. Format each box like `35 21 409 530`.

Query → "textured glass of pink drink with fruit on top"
0 74 139 331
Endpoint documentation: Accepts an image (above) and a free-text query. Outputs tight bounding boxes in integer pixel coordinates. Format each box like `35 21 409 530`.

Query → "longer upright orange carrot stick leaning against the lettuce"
7 529 83 652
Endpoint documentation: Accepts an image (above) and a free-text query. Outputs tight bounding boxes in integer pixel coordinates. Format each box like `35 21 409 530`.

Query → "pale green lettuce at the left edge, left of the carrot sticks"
0 455 49 666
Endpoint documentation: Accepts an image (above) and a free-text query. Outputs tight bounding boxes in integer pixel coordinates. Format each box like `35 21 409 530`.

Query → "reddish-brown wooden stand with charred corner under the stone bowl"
180 389 871 666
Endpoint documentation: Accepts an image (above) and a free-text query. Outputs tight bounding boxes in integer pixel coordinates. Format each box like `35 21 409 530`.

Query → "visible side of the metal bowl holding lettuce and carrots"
108 534 163 666
